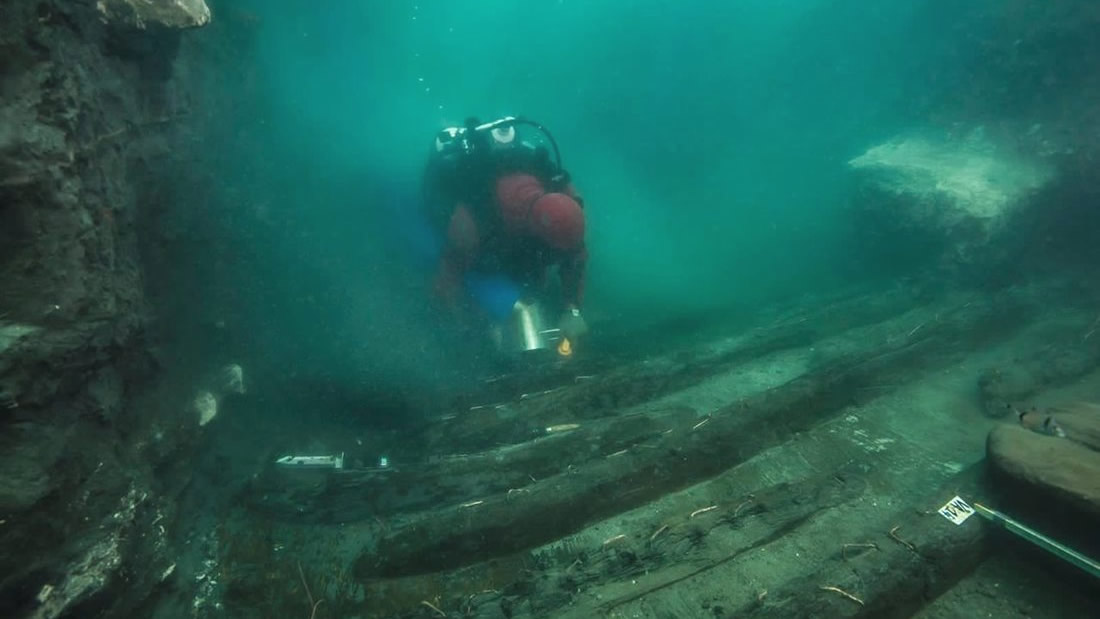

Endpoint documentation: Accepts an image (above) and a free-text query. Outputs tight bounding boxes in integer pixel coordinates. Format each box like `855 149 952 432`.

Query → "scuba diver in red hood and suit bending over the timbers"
424 117 587 356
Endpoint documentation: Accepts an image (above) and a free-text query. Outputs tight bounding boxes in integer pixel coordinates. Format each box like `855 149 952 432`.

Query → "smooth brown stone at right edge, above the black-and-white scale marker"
987 424 1100 515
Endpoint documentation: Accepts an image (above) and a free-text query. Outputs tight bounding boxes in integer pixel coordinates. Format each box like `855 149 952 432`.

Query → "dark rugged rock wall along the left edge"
0 0 210 617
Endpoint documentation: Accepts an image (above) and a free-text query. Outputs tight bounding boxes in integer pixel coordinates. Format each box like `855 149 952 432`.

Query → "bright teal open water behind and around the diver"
180 0 1029 391
